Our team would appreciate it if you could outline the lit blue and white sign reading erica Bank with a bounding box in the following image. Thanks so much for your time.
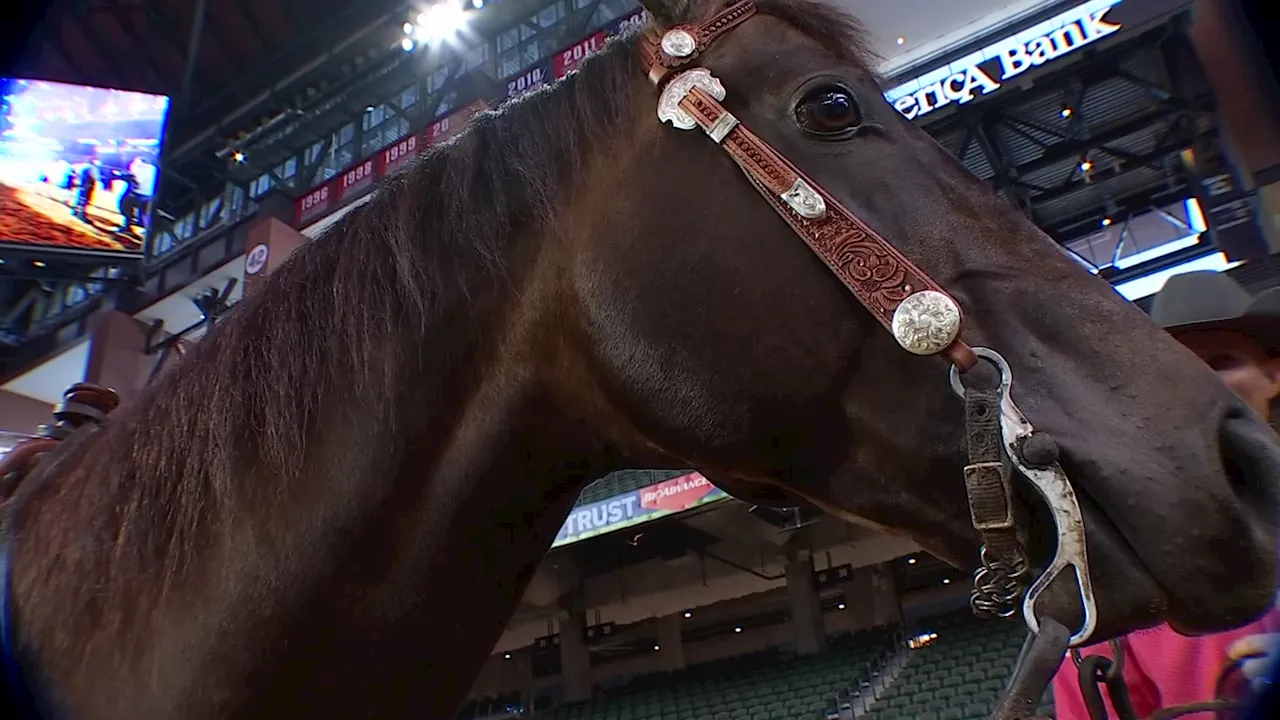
[884,0,1121,120]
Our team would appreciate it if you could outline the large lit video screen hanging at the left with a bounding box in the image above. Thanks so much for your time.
[0,78,169,252]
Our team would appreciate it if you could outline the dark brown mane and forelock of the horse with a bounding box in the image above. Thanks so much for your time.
[17,0,873,657]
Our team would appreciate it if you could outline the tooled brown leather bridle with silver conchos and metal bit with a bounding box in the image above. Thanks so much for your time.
[640,0,1097,717]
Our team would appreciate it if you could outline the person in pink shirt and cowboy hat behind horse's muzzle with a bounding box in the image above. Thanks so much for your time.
[1053,272,1280,720]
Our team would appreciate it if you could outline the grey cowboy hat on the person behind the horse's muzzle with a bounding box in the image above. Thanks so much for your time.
[1151,270,1280,354]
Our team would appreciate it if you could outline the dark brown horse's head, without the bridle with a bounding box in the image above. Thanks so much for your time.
[571,0,1280,637]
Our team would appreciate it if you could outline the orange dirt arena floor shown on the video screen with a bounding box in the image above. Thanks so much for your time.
[0,184,142,251]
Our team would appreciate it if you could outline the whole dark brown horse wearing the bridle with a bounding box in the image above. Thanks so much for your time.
[9,0,1280,720]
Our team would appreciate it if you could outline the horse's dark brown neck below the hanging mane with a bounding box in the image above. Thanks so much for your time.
[14,265,602,719]
